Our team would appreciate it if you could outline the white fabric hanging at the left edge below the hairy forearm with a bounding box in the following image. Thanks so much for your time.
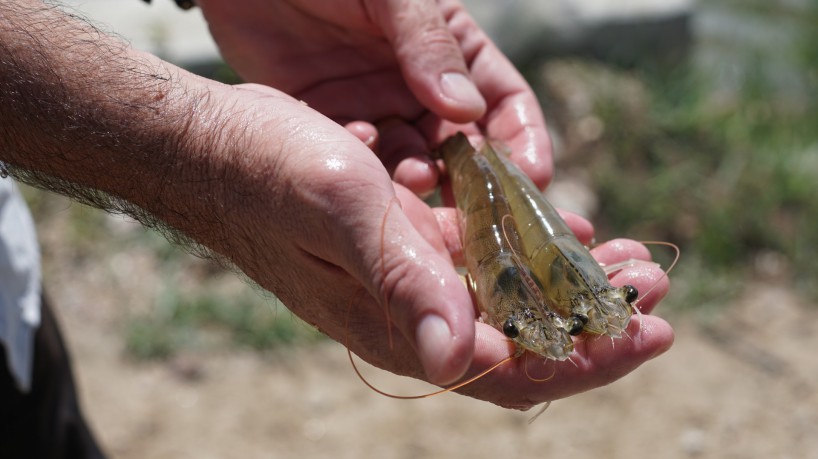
[0,178,40,391]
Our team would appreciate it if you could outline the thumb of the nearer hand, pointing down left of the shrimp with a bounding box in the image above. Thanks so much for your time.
[372,192,475,385]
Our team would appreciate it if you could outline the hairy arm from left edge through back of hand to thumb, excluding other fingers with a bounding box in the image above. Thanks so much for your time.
[0,0,474,390]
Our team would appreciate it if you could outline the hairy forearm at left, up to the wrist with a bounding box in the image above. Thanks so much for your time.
[0,1,242,255]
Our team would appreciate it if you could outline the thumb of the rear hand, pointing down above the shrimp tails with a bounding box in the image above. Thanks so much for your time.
[370,0,486,123]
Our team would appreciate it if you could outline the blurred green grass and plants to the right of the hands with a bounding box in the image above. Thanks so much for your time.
[542,2,818,306]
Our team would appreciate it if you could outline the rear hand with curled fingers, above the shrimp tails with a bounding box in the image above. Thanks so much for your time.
[197,0,551,195]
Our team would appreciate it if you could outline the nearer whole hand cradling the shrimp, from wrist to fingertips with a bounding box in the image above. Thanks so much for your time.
[196,82,672,408]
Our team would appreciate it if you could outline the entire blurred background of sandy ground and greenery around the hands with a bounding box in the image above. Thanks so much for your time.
[25,0,818,459]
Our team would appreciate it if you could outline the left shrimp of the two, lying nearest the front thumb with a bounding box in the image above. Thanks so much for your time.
[440,134,574,360]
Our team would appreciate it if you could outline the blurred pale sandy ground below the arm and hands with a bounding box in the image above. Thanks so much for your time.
[30,200,818,459]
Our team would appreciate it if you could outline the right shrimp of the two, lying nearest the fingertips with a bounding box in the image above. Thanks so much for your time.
[481,142,639,338]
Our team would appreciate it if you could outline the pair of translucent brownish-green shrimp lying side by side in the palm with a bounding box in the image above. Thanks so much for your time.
[440,133,656,360]
